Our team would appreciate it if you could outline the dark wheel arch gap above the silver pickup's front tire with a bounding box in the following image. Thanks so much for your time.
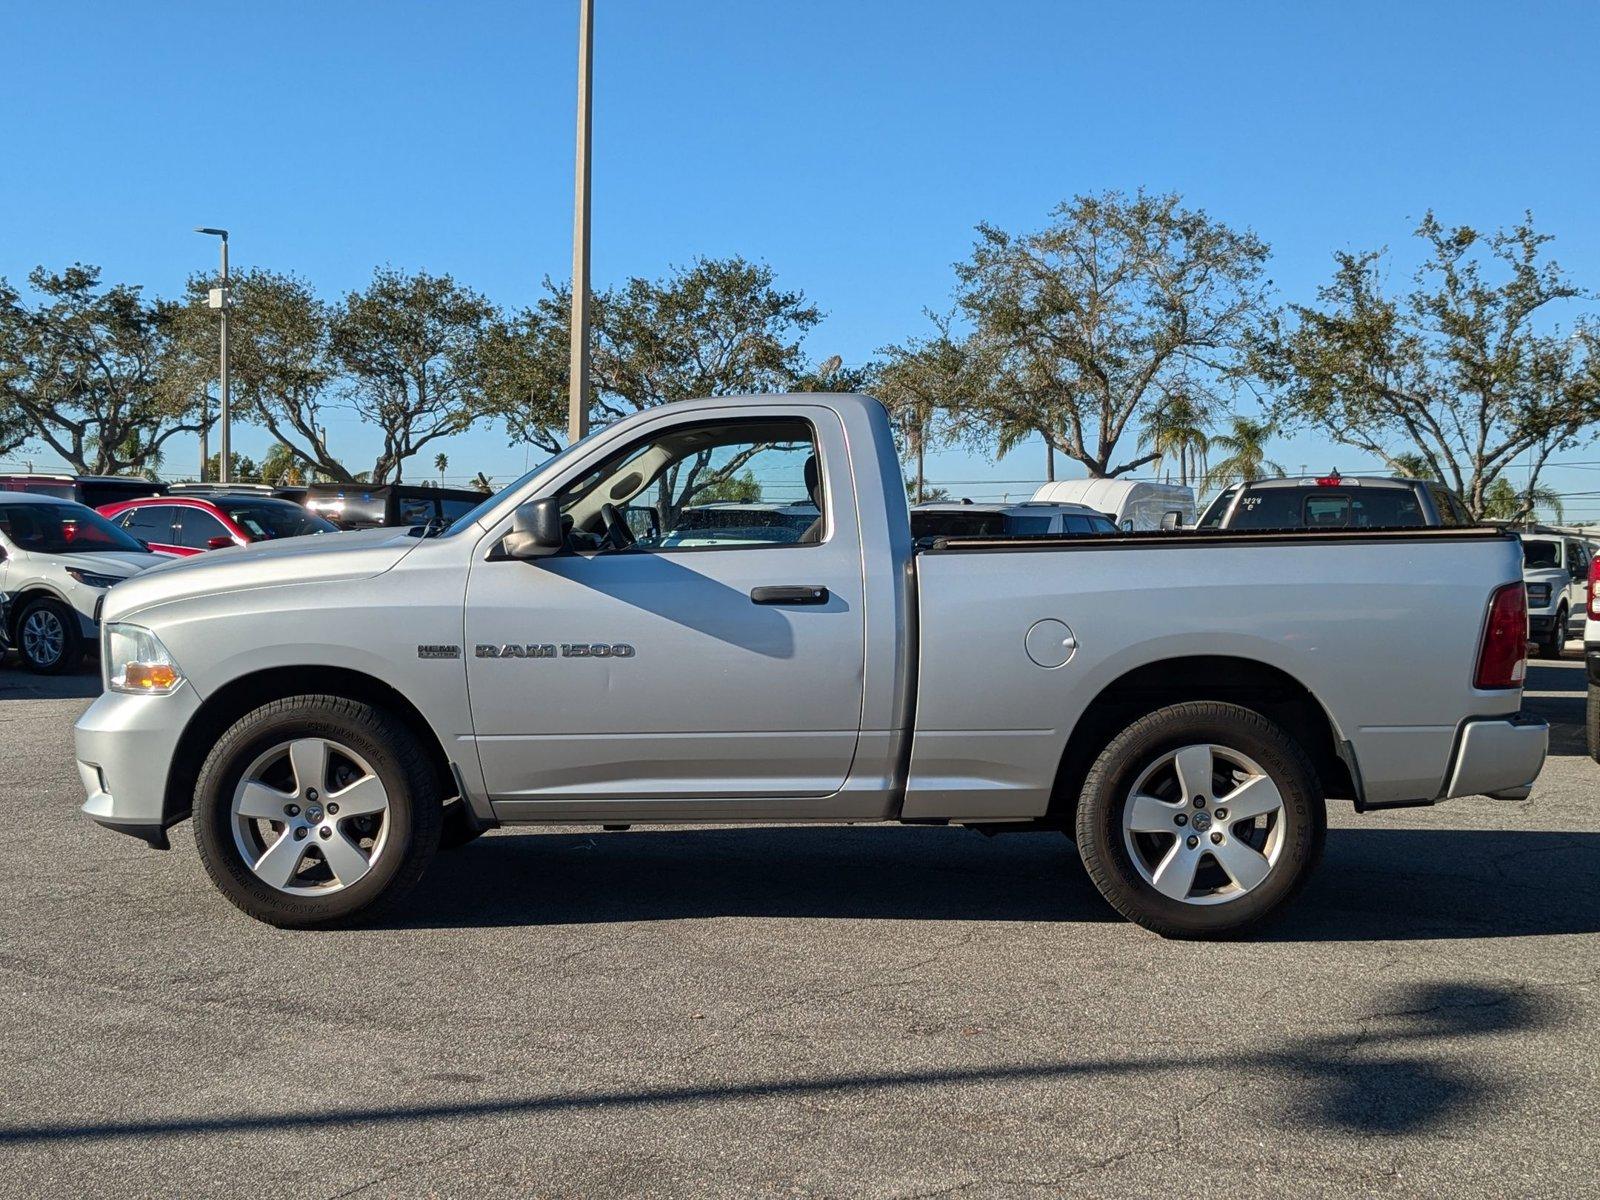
[162,664,459,827]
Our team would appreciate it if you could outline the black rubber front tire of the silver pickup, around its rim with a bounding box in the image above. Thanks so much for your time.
[194,696,442,930]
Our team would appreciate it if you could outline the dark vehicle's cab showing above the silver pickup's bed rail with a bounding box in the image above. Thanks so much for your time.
[1200,470,1477,530]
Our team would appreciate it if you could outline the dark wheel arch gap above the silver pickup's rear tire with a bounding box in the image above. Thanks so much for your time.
[1050,654,1360,829]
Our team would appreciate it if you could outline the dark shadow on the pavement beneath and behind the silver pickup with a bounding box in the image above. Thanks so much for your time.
[384,826,1600,942]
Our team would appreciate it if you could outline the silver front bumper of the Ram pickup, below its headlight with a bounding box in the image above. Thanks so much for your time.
[72,683,200,845]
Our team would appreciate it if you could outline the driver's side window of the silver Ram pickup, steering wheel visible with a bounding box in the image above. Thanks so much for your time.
[560,418,826,552]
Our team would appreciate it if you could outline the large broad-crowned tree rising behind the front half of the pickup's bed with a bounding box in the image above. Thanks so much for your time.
[955,190,1269,477]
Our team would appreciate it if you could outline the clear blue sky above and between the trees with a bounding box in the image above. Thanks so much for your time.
[0,0,1600,514]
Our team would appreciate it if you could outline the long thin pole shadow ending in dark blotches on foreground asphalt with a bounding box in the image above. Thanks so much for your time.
[0,982,1573,1154]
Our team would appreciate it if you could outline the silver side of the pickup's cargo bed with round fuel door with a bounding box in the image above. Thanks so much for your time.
[902,528,1522,821]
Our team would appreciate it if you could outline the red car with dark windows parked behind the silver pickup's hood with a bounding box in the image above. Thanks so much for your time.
[99,488,336,555]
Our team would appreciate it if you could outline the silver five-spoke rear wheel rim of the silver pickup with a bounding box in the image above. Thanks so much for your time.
[1122,742,1285,904]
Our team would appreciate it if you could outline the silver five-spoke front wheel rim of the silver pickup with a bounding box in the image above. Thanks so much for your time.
[232,738,390,896]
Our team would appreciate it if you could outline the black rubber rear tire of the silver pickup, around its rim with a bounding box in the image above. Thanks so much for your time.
[1077,701,1328,938]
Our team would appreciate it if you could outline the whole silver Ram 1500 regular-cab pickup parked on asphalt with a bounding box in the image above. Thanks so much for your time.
[77,395,1547,936]
